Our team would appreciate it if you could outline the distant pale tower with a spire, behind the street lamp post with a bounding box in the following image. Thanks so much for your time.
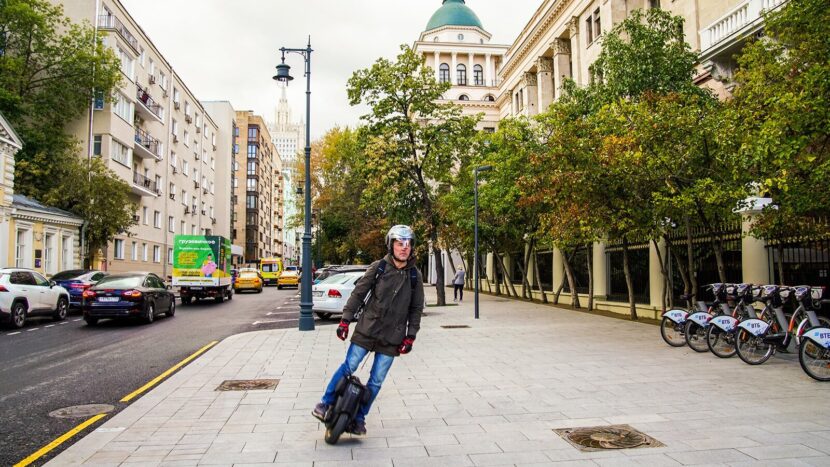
[268,83,305,265]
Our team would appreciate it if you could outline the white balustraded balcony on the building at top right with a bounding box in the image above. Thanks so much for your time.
[699,0,787,61]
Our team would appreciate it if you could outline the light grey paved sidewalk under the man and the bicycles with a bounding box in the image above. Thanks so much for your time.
[47,289,830,467]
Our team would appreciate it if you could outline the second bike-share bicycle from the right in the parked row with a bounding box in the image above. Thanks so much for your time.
[736,285,830,370]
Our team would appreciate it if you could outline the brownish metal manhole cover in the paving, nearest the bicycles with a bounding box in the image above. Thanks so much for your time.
[553,425,663,451]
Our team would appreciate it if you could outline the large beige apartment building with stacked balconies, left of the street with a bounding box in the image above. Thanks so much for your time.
[53,0,228,277]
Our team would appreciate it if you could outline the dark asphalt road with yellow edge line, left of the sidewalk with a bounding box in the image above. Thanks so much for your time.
[0,288,336,465]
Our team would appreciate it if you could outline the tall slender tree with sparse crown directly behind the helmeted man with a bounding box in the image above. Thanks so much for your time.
[348,45,477,305]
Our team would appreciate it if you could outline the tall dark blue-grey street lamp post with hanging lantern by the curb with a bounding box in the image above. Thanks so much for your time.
[274,36,314,331]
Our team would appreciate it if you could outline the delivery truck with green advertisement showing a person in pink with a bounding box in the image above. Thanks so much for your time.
[173,235,233,305]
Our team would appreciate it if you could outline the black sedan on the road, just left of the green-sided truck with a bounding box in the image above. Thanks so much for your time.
[83,272,176,326]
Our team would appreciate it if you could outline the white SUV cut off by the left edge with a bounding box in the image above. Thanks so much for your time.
[0,268,69,329]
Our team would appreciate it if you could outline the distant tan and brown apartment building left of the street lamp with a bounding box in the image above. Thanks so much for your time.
[236,110,281,263]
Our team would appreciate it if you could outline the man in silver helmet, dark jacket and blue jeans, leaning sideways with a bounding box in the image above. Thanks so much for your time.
[312,225,424,435]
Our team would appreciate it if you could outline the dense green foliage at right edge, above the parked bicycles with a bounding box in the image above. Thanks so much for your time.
[733,0,830,238]
